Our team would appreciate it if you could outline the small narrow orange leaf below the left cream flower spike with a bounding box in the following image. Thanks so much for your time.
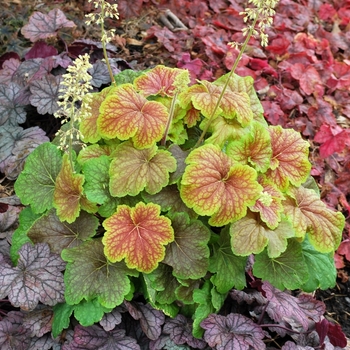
[53,154,84,223]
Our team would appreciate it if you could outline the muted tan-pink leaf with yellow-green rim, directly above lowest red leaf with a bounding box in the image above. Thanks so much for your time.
[109,141,176,197]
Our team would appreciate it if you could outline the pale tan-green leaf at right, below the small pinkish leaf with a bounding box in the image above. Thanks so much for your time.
[230,212,295,258]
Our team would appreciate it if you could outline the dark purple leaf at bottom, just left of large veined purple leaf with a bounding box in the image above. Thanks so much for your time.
[163,314,207,349]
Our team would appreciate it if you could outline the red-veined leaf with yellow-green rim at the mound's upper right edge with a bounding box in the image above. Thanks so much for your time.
[266,126,311,190]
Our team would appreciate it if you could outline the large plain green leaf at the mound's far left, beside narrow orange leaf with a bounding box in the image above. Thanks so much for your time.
[15,142,62,214]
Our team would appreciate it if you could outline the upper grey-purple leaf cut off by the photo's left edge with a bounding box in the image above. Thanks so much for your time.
[0,82,27,126]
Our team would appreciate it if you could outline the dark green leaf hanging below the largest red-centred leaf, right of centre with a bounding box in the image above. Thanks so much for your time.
[209,228,247,294]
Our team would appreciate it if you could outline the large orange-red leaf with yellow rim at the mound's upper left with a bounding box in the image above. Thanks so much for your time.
[97,84,168,148]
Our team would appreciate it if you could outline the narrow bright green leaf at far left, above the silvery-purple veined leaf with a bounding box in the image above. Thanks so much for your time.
[10,207,40,266]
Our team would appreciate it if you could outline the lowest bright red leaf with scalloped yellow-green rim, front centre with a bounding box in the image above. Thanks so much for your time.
[102,202,174,273]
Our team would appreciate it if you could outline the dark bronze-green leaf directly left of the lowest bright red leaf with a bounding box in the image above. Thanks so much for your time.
[27,209,99,254]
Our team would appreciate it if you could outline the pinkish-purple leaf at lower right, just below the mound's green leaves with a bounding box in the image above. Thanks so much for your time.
[262,282,325,331]
